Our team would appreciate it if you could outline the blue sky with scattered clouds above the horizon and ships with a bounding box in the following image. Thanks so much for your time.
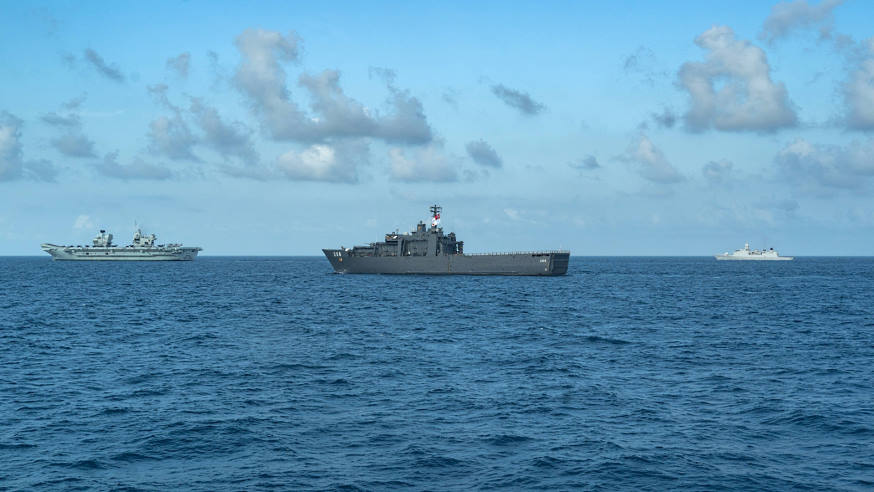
[0,0,874,256]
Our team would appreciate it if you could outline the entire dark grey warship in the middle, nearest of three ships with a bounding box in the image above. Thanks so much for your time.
[322,205,570,275]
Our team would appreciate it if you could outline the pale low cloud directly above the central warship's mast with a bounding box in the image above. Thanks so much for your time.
[389,142,458,182]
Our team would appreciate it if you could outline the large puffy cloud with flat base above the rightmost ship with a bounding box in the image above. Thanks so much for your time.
[678,26,797,132]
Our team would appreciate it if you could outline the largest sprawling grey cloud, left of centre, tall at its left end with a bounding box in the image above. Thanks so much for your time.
[234,29,432,144]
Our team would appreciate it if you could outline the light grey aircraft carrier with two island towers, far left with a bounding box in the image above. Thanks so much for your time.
[42,228,203,261]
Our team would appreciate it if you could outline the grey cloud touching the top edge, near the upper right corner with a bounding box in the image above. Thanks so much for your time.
[759,0,844,42]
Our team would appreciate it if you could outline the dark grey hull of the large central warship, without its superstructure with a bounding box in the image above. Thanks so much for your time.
[322,249,570,276]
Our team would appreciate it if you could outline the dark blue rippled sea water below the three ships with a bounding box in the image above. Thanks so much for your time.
[0,257,874,490]
